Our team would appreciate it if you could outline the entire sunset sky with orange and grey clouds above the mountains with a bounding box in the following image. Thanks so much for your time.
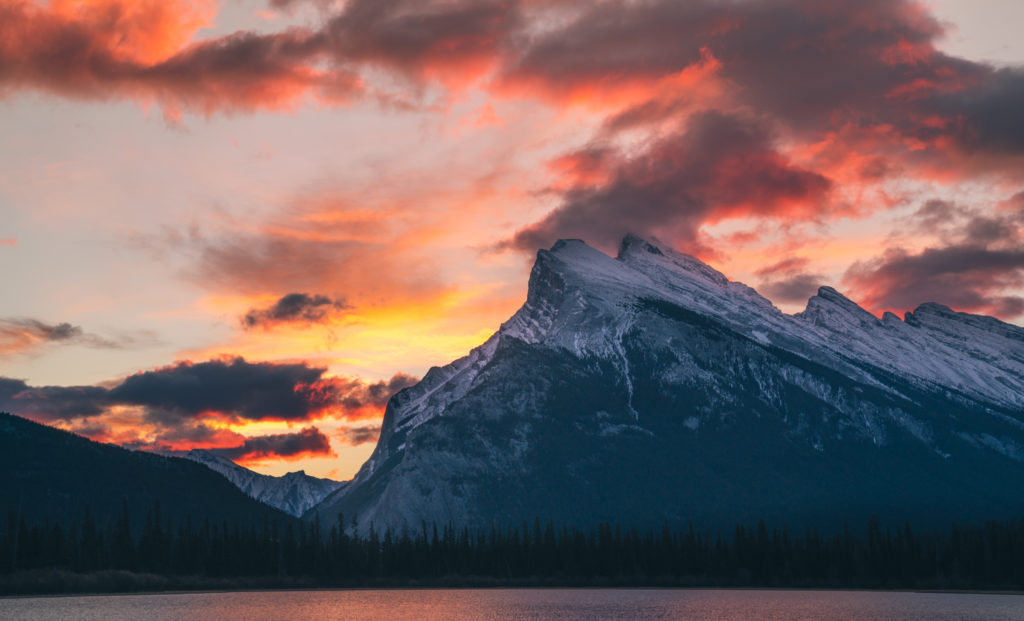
[0,0,1024,479]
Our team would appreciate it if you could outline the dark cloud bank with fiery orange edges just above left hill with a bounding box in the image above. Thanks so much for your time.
[0,358,417,460]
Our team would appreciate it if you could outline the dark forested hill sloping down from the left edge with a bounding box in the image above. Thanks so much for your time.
[0,414,292,528]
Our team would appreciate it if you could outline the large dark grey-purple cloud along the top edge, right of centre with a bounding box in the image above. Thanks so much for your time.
[505,0,966,125]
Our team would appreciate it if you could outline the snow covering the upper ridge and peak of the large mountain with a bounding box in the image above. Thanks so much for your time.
[385,236,1024,446]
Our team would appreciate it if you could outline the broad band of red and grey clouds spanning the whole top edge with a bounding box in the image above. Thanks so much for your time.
[0,0,1024,182]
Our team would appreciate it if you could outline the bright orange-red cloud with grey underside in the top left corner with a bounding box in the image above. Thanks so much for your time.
[0,0,348,114]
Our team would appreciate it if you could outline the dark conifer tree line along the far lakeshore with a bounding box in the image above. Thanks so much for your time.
[0,503,1024,589]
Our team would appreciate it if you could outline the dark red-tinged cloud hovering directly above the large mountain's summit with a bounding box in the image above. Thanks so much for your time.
[506,112,831,251]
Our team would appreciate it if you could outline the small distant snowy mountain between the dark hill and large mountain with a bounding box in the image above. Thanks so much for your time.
[181,449,345,516]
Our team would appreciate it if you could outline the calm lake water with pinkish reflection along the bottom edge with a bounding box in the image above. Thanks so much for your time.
[0,589,1024,621]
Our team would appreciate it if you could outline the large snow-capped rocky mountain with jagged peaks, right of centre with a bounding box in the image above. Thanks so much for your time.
[307,237,1024,529]
